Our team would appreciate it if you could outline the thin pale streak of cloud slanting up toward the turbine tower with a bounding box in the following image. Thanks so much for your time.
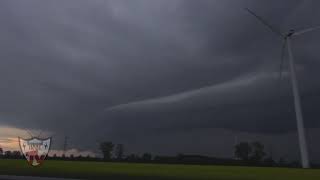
[106,73,278,112]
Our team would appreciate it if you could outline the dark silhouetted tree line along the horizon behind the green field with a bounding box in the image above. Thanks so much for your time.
[0,141,320,167]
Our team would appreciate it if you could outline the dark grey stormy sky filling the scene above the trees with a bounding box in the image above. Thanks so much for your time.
[0,0,320,160]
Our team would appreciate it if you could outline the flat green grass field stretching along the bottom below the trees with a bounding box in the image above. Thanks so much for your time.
[0,160,320,180]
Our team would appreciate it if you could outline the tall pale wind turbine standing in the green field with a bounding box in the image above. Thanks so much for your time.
[245,8,320,168]
